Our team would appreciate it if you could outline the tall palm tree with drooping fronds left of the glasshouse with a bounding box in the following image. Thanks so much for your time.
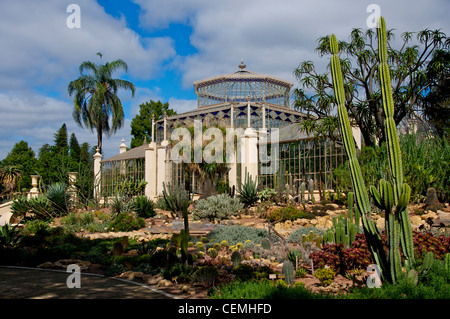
[67,52,135,153]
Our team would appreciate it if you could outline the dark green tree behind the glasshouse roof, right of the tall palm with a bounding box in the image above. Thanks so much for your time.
[131,100,177,148]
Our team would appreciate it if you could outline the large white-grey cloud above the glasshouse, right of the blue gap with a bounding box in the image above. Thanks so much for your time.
[135,0,450,88]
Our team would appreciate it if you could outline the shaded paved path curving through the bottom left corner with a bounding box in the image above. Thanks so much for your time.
[0,266,176,299]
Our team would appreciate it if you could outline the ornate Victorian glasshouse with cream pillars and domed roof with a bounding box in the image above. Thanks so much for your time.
[95,61,360,198]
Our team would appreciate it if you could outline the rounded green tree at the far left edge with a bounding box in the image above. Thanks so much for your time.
[1,141,37,189]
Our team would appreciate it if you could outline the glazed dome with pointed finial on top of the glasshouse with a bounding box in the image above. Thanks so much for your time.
[194,61,293,108]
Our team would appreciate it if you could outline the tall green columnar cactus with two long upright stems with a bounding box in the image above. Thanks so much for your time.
[330,17,414,282]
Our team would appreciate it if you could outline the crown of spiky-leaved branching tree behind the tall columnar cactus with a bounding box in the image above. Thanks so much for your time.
[293,28,450,146]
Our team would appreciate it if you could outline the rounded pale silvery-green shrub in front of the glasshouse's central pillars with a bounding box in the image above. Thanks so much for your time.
[192,194,244,222]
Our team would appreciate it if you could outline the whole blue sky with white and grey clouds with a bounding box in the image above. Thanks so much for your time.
[0,0,450,159]
